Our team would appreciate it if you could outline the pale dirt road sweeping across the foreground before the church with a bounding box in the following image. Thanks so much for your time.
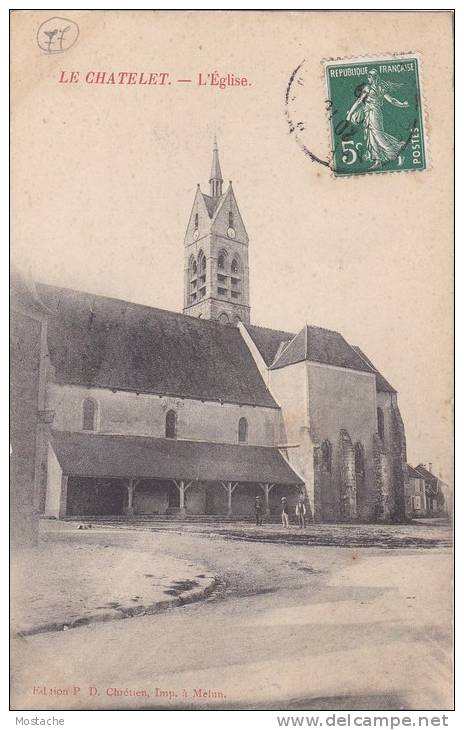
[12,527,452,710]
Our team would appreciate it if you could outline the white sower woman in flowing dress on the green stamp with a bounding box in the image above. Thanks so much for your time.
[346,69,409,170]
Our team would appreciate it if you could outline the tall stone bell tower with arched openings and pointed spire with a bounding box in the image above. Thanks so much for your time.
[183,137,250,325]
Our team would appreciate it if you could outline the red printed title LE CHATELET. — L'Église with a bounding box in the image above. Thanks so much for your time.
[58,71,251,89]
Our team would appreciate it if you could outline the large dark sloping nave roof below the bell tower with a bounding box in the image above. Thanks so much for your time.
[38,284,278,408]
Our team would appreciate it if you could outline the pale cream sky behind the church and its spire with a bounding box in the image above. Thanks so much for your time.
[12,11,453,480]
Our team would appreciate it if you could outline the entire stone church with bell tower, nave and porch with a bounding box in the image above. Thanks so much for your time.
[29,141,407,521]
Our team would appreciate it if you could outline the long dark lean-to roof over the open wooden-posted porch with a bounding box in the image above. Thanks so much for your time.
[51,431,303,484]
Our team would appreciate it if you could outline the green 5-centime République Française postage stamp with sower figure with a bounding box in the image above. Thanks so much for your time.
[324,54,428,177]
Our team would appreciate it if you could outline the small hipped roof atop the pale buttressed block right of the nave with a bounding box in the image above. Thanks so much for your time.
[271,325,372,373]
